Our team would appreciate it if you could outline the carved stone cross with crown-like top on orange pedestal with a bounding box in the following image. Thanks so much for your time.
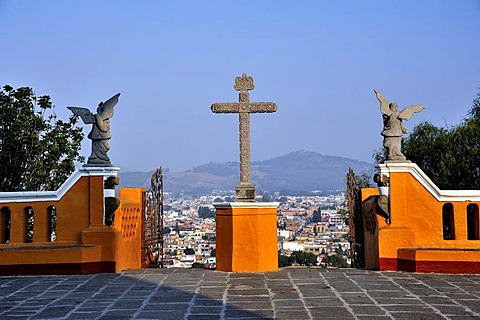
[210,73,277,202]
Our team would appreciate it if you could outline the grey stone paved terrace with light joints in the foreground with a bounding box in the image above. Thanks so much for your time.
[0,268,480,320]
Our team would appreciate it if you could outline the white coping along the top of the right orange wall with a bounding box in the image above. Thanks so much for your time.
[375,162,480,202]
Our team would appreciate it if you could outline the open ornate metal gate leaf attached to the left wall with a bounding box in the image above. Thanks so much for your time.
[142,167,163,268]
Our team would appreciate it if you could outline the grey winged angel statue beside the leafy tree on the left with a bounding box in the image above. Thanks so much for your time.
[67,93,120,167]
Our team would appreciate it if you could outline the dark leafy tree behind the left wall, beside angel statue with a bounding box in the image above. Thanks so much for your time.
[0,85,84,192]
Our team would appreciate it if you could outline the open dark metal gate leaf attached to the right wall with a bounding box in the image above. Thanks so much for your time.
[347,168,365,268]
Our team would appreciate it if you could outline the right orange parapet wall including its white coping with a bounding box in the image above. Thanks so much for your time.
[362,163,480,273]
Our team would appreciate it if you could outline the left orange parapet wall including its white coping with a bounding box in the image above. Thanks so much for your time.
[0,167,143,275]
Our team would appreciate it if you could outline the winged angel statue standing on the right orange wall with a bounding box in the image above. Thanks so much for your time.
[373,90,425,162]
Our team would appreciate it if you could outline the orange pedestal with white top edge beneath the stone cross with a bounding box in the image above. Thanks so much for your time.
[214,202,278,272]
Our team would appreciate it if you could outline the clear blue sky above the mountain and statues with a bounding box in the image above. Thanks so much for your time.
[0,0,480,171]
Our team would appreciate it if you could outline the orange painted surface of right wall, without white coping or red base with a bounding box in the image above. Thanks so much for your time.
[362,165,480,270]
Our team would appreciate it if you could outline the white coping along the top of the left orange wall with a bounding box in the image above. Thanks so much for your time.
[0,167,120,203]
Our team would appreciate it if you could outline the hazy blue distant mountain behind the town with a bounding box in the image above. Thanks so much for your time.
[120,151,373,194]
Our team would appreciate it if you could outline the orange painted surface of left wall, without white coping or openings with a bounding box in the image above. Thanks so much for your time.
[0,171,144,274]
